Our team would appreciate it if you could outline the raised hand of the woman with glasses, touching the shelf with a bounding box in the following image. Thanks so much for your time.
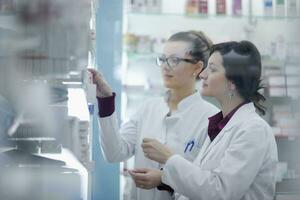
[88,69,113,97]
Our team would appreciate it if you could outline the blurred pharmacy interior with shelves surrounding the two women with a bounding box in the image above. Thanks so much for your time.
[0,0,300,200]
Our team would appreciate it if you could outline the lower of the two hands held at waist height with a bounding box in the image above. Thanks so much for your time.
[128,168,161,190]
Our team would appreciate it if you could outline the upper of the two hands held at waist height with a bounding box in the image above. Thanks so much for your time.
[142,138,174,164]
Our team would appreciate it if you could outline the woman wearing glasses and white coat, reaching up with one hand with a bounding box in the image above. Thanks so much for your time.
[89,31,218,200]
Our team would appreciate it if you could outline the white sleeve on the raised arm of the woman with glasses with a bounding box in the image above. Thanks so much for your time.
[98,104,143,162]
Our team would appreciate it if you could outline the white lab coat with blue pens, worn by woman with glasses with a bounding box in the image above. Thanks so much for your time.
[99,92,218,200]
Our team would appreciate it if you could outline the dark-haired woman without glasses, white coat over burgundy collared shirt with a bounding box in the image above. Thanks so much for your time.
[136,41,277,200]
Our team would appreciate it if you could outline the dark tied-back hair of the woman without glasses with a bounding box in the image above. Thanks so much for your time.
[210,41,266,115]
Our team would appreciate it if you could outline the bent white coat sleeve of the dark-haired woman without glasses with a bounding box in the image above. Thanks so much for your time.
[162,123,268,200]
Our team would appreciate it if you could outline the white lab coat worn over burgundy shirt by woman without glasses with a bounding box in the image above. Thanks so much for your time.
[162,103,277,200]
